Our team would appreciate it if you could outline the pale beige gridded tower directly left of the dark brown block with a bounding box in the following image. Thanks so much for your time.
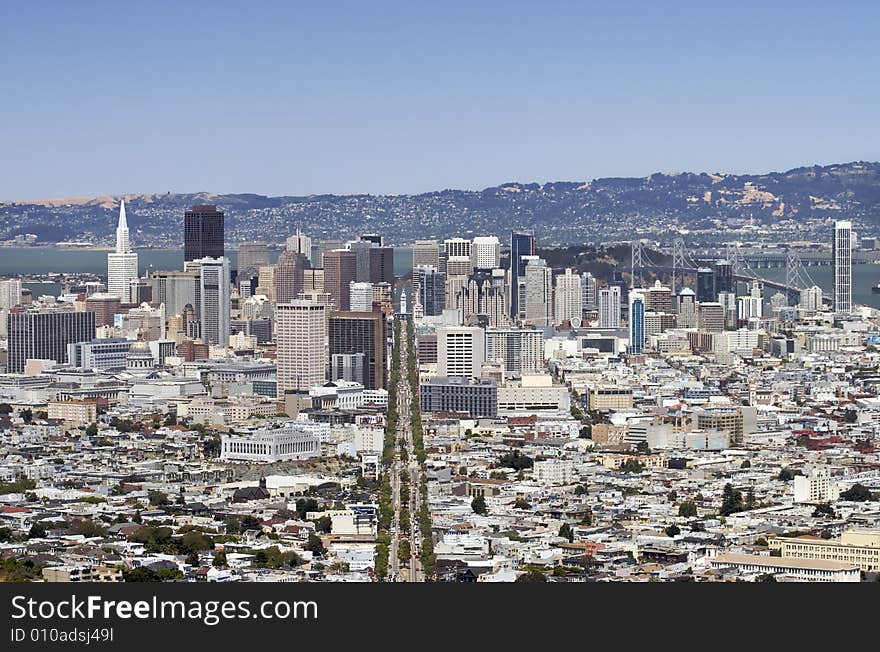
[275,301,327,399]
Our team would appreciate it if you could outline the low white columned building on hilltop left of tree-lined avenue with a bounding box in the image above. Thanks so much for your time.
[220,422,321,463]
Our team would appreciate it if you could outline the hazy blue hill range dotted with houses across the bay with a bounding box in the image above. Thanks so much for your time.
[0,162,880,247]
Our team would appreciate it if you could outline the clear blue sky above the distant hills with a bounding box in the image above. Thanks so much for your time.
[0,0,880,200]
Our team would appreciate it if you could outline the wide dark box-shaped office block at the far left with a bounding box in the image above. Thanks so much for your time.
[6,308,95,374]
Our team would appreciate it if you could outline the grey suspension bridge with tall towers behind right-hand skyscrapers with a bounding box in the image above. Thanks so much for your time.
[630,238,832,303]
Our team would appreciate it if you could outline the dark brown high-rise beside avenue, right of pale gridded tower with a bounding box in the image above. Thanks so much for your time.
[328,311,385,389]
